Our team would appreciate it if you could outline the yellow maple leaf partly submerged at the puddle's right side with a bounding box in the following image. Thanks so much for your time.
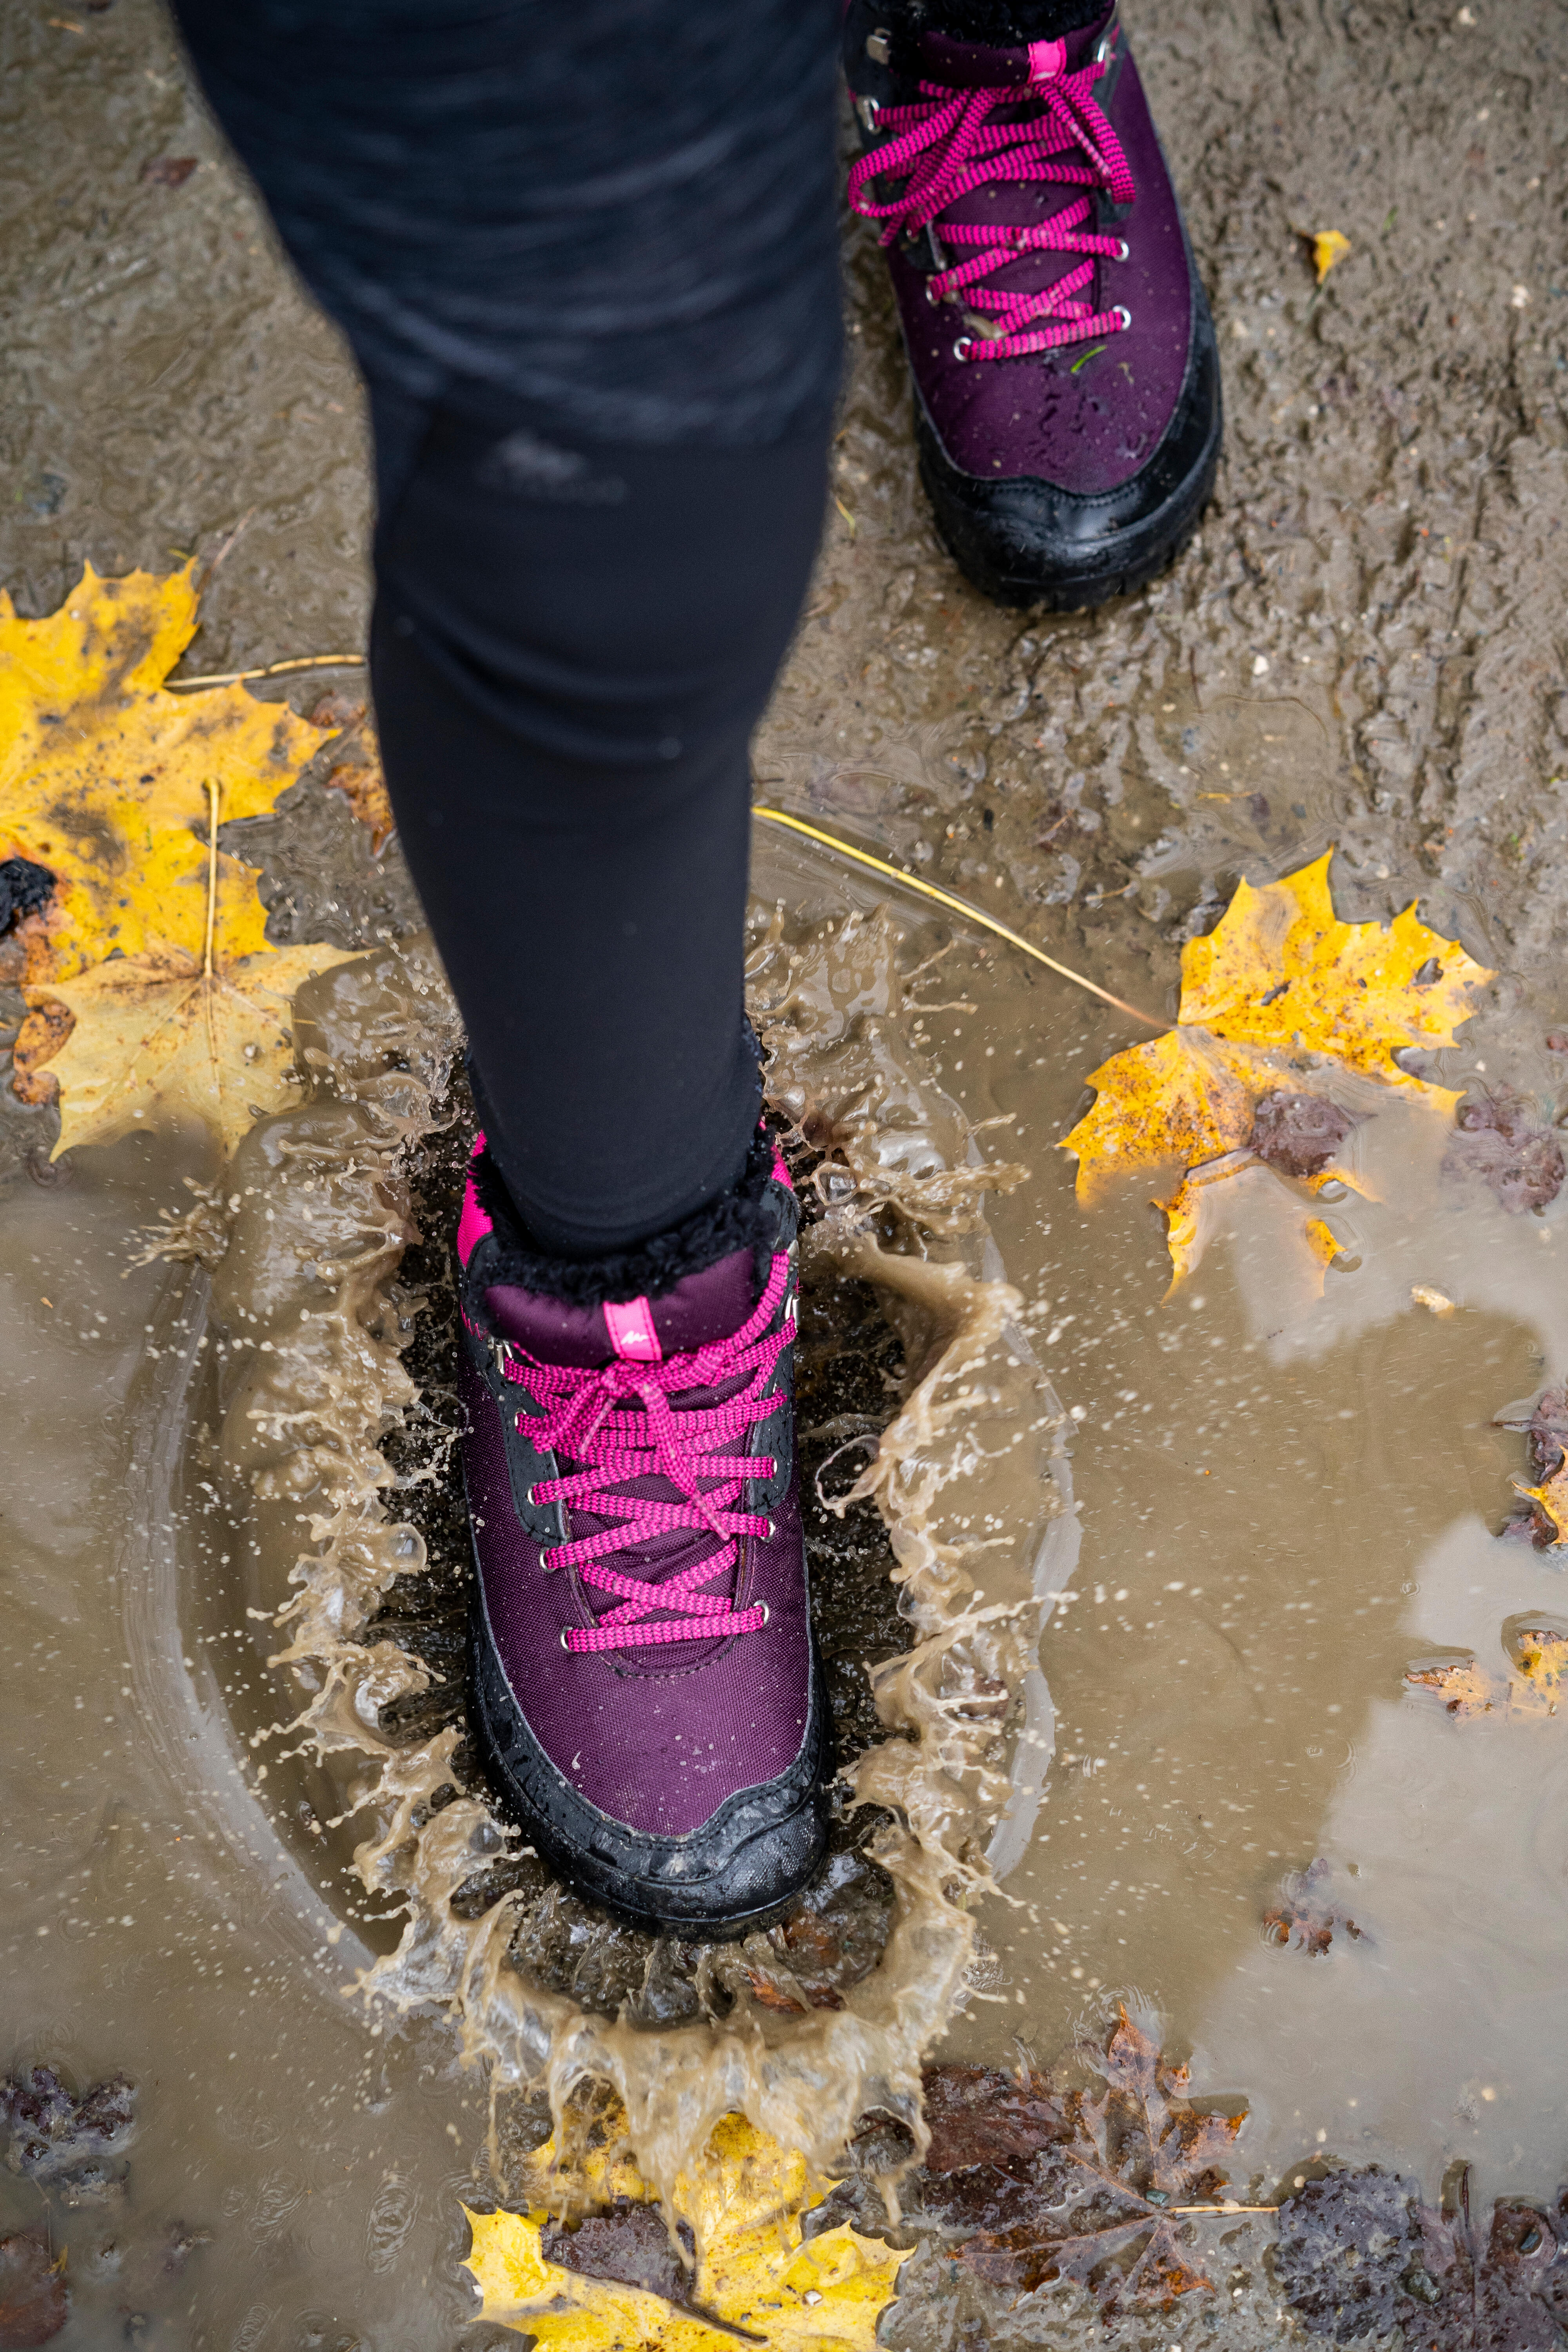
[1063,851,1493,1279]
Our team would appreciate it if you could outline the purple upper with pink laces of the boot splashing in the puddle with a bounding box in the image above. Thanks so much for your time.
[458,1138,818,1851]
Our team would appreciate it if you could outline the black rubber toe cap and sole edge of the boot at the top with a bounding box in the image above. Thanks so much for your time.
[915,275,1225,612]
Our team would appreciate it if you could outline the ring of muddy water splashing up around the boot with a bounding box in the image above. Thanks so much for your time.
[158,910,1063,2192]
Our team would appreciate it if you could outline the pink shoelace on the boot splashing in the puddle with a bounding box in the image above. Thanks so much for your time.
[503,1251,795,1653]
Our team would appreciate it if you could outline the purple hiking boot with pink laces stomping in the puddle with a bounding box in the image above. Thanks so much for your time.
[458,1134,828,1936]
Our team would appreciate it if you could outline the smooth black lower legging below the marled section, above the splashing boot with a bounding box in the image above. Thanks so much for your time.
[372,395,828,1256]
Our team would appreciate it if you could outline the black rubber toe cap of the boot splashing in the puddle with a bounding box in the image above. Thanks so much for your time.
[468,1573,832,1943]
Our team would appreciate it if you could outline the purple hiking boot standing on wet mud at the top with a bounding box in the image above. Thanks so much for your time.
[844,0,1222,612]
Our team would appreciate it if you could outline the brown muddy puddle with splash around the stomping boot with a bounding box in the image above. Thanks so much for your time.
[0,804,1568,2352]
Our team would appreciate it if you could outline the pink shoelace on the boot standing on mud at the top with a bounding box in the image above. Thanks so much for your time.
[849,42,1133,360]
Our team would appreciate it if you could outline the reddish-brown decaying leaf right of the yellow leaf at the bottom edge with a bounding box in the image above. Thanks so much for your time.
[924,2009,1243,2314]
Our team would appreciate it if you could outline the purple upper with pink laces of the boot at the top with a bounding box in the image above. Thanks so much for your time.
[846,7,1194,494]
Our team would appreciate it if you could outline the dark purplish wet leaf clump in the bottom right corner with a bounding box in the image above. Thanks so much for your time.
[1272,2164,1568,2352]
